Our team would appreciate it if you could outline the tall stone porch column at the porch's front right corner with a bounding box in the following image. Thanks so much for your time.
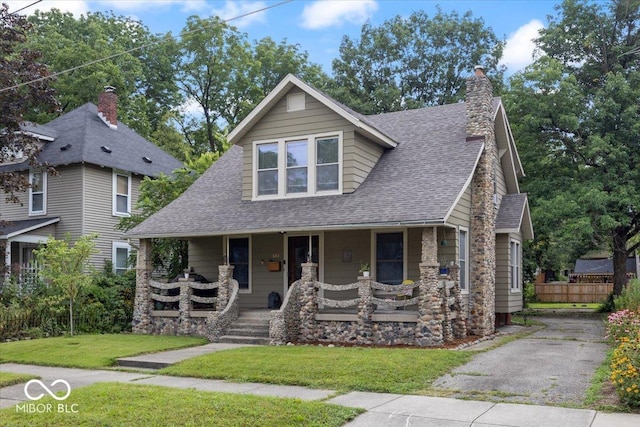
[416,227,443,347]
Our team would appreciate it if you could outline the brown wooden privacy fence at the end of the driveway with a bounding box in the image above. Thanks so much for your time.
[535,282,613,303]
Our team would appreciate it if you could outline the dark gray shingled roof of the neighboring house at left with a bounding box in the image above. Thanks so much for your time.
[0,103,183,176]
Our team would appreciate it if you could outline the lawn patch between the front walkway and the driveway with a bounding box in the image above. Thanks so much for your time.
[160,346,475,394]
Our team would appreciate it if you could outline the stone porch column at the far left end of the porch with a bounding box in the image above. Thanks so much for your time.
[131,239,153,334]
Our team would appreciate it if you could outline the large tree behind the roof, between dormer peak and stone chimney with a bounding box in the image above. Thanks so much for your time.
[330,8,504,114]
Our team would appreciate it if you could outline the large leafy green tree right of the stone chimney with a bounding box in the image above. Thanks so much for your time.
[508,0,640,294]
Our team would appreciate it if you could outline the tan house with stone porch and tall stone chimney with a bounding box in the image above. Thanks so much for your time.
[129,68,533,345]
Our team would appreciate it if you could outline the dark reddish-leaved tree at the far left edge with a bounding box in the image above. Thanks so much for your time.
[0,4,58,204]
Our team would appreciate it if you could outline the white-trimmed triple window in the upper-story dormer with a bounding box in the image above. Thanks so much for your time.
[253,132,342,199]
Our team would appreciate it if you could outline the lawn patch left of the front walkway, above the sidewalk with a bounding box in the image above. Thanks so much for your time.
[0,334,207,368]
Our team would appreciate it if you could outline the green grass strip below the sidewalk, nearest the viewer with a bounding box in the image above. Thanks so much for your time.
[0,383,364,427]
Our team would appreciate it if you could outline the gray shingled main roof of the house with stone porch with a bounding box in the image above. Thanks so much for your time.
[128,103,482,237]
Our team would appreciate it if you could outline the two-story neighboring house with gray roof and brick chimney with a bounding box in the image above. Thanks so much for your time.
[0,87,182,281]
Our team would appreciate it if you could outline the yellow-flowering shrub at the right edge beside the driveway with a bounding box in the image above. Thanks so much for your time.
[611,333,640,406]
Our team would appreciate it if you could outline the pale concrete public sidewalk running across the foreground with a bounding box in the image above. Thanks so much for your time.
[0,362,640,427]
